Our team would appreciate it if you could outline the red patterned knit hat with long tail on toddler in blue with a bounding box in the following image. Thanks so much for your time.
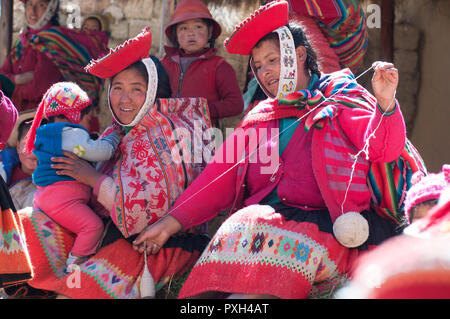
[25,82,92,153]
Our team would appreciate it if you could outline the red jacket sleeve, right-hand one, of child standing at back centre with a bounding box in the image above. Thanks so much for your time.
[208,62,244,119]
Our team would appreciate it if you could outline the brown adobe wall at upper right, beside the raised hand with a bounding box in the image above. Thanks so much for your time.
[362,0,450,172]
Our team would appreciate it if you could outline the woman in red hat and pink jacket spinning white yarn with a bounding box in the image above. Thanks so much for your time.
[134,1,426,298]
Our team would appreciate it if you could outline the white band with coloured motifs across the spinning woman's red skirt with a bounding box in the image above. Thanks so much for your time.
[197,223,337,283]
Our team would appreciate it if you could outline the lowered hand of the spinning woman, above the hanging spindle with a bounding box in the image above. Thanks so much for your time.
[133,215,181,255]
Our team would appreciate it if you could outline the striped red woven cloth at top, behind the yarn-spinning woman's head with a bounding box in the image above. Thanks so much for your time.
[289,0,368,70]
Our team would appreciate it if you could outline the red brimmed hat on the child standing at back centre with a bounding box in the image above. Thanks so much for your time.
[166,0,222,39]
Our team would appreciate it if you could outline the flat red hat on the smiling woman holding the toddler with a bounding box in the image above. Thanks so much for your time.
[84,27,152,79]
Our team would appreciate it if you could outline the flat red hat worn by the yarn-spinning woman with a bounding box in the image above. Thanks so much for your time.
[224,0,289,55]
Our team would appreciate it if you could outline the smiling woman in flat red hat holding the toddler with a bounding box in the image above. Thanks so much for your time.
[14,28,215,299]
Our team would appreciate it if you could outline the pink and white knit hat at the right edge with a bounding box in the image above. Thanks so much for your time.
[405,164,450,222]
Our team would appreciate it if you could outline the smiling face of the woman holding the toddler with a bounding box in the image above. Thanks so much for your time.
[109,68,147,125]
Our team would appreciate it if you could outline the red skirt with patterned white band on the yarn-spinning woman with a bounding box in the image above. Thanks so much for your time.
[179,205,358,299]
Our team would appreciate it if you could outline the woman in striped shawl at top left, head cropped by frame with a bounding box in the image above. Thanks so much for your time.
[0,0,107,111]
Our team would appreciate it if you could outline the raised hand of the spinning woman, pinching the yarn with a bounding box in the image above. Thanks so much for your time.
[372,61,398,112]
